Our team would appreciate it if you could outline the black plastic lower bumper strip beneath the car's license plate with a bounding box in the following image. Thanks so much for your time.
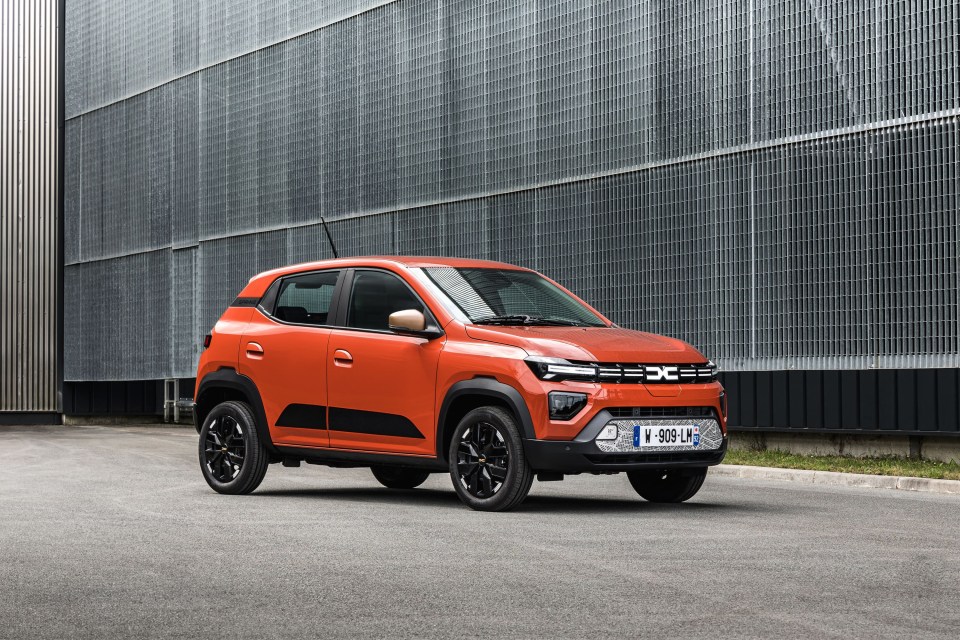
[523,437,727,473]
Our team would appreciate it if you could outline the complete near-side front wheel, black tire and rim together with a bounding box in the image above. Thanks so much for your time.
[448,407,533,511]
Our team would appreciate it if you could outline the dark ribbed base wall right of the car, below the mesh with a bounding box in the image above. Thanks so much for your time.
[720,369,960,435]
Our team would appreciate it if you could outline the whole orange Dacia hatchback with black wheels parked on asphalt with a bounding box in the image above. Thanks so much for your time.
[194,257,727,511]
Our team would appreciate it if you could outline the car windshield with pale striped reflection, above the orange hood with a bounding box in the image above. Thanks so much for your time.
[424,267,606,327]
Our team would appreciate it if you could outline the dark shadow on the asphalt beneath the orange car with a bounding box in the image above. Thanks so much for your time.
[253,487,781,514]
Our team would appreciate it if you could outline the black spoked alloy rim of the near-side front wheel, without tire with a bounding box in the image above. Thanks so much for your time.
[457,422,510,499]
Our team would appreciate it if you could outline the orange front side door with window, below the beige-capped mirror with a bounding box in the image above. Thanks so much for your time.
[327,269,443,456]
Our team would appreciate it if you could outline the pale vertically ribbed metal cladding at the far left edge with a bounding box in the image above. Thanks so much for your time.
[0,0,60,412]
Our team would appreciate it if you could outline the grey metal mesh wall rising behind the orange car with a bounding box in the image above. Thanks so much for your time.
[65,0,960,380]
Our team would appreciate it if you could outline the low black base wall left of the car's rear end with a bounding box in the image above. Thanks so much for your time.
[63,378,194,416]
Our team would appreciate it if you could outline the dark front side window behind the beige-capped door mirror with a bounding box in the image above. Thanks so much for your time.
[347,271,429,331]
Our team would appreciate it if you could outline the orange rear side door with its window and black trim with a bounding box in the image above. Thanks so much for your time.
[239,270,343,447]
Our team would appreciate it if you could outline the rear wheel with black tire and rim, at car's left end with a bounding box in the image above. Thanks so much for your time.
[199,400,270,495]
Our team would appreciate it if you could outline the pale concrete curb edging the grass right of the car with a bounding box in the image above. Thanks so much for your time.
[710,464,960,495]
